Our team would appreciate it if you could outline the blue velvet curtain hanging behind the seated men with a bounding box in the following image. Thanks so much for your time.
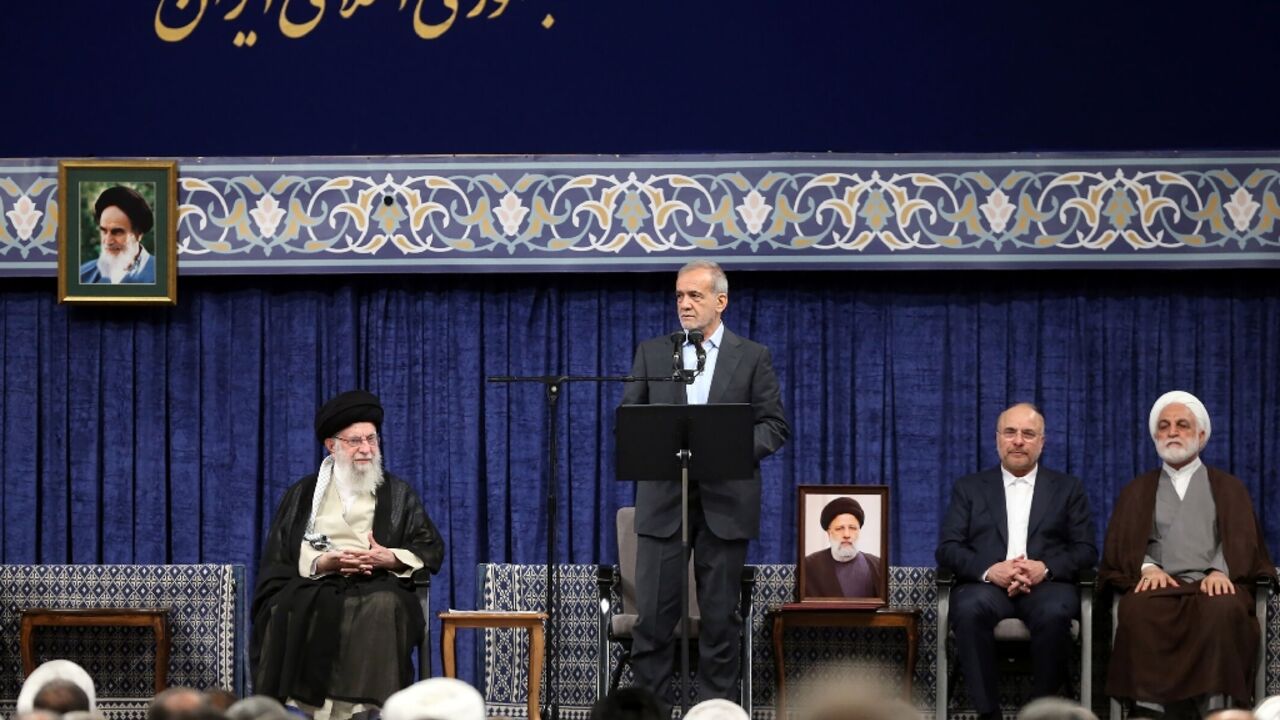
[0,270,1280,667]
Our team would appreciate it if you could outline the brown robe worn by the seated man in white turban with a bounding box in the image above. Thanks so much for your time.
[1098,465,1275,706]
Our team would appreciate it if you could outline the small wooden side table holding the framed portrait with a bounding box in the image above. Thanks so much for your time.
[772,602,920,720]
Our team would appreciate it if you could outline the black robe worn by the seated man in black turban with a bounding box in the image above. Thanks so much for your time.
[250,473,444,706]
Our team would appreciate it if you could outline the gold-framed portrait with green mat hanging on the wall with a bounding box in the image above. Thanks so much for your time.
[58,160,178,305]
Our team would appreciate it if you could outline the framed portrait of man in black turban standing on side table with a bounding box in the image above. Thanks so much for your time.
[796,486,888,609]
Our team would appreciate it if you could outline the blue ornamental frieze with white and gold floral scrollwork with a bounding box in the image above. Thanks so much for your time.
[0,154,1280,275]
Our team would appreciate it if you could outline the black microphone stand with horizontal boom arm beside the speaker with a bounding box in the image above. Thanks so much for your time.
[486,364,700,720]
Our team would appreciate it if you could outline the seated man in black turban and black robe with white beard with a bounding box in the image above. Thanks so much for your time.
[250,391,444,720]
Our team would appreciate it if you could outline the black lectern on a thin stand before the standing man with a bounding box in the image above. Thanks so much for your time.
[616,404,755,715]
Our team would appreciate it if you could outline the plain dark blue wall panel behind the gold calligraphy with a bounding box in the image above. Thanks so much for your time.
[10,0,1280,158]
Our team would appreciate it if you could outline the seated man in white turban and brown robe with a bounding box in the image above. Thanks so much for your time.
[1098,391,1275,714]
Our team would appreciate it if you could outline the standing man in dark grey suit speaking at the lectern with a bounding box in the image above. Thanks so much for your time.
[622,260,791,705]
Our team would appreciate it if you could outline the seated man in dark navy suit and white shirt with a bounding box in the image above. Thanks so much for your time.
[937,402,1098,717]
